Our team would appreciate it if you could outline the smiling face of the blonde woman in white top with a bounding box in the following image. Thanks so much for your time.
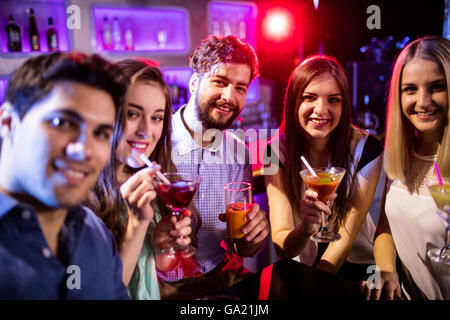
[401,58,448,139]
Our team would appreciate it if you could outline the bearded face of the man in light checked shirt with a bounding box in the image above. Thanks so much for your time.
[194,63,251,130]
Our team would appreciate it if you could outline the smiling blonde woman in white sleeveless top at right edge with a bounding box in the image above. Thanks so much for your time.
[366,37,450,299]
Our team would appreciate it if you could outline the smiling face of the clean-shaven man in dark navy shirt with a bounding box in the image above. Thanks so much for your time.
[6,82,115,208]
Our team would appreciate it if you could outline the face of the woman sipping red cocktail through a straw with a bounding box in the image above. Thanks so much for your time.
[116,81,166,168]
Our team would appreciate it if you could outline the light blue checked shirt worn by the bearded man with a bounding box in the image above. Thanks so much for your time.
[171,106,252,280]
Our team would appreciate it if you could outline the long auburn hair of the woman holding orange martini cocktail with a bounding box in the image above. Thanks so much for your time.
[280,55,352,228]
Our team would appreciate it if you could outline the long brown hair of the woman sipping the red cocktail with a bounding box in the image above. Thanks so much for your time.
[86,58,175,247]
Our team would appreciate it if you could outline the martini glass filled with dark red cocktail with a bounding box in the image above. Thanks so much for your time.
[155,172,202,258]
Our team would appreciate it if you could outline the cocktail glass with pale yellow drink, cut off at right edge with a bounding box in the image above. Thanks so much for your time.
[427,178,450,265]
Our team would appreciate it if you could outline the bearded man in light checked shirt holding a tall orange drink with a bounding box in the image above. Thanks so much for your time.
[160,36,269,297]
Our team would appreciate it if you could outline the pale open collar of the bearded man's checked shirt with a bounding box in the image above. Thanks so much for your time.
[172,105,224,158]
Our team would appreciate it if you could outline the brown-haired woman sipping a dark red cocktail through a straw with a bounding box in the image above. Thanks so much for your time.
[86,59,197,299]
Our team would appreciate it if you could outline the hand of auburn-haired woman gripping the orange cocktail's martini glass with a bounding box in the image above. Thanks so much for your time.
[300,190,336,235]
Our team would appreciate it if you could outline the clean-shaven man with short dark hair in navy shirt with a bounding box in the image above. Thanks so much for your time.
[0,53,128,299]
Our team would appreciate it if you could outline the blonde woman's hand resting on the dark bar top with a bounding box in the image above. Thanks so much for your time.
[360,271,403,300]
